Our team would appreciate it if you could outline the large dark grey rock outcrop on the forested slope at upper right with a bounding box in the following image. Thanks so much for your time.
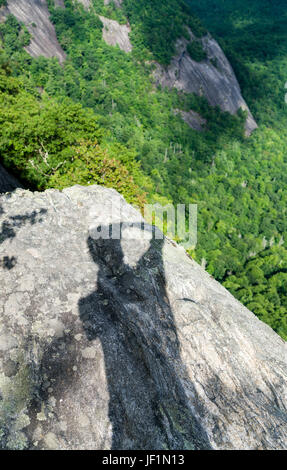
[154,31,257,135]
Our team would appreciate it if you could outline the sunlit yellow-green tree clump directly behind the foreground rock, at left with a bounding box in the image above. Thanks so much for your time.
[0,65,148,207]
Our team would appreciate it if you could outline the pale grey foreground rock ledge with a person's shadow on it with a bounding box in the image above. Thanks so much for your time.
[0,186,287,449]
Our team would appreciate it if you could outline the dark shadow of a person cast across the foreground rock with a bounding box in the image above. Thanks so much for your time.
[79,223,211,449]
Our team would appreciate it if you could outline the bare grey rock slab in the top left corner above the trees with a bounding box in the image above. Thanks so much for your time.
[0,0,66,63]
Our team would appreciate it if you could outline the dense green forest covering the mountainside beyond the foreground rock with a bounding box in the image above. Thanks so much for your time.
[0,0,287,339]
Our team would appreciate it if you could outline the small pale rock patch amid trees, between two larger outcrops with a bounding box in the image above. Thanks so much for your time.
[99,16,132,52]
